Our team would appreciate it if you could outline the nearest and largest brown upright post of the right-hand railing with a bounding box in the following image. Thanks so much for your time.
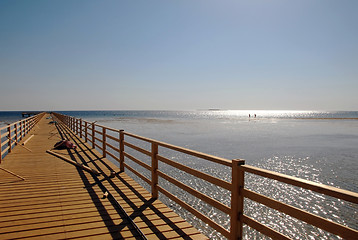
[230,159,245,240]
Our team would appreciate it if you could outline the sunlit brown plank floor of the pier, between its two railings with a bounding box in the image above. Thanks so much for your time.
[0,115,207,240]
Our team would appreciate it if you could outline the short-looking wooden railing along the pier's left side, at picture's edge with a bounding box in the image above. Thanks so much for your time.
[0,113,45,163]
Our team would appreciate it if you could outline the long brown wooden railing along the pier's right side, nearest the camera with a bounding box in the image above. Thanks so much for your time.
[54,113,358,239]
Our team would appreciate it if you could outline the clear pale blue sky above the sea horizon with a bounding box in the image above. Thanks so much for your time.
[0,0,358,110]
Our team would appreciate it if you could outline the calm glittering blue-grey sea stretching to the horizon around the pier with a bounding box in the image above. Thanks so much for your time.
[0,110,358,239]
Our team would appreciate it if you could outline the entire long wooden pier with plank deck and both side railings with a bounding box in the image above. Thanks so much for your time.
[0,113,358,240]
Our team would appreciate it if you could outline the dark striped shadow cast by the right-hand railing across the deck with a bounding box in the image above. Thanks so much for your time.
[56,121,204,239]
